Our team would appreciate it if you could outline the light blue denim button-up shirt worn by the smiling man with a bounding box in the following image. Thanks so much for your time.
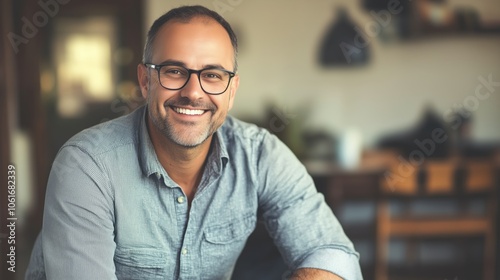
[27,107,362,280]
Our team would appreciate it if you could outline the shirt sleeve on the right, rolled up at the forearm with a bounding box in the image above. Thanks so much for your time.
[256,133,363,280]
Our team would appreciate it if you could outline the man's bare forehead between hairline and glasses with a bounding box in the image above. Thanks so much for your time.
[153,17,234,67]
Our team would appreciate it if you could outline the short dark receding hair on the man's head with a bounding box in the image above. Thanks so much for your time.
[142,5,238,71]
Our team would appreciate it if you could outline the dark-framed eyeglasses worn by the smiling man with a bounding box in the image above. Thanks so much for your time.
[144,63,236,95]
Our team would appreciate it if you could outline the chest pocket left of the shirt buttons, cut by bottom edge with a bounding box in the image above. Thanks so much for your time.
[114,248,167,280]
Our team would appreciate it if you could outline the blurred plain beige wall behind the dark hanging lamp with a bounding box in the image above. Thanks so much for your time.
[144,0,500,146]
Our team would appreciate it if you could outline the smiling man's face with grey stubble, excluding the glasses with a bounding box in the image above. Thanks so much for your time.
[138,18,239,147]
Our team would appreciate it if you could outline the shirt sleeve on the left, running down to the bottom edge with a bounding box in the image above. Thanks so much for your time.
[42,146,116,279]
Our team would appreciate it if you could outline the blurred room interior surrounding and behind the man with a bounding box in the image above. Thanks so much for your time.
[0,0,500,280]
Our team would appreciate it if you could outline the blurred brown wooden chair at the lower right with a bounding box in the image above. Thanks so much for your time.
[375,159,498,280]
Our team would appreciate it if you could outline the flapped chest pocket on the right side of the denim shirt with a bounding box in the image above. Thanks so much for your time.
[201,214,256,279]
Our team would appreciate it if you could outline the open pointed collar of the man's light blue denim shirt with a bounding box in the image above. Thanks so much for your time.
[138,105,229,177]
